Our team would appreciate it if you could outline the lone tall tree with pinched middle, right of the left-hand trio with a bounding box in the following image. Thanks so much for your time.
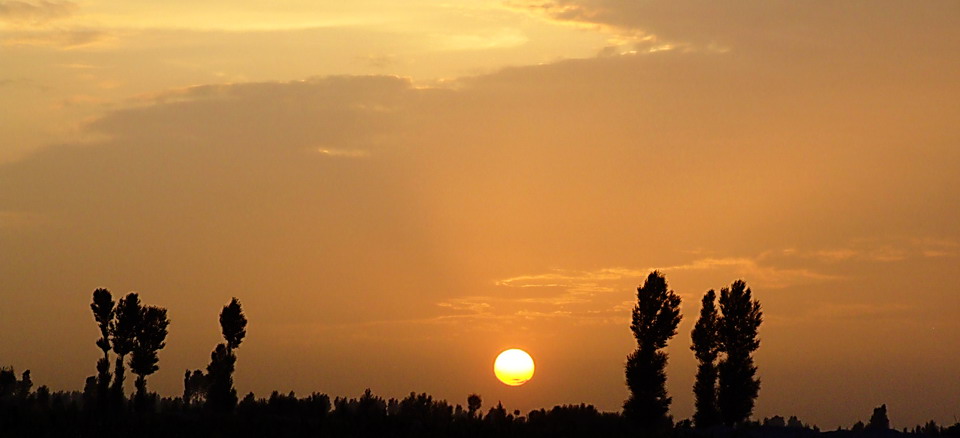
[207,297,247,412]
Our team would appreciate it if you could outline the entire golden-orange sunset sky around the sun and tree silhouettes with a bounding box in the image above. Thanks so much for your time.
[0,0,960,428]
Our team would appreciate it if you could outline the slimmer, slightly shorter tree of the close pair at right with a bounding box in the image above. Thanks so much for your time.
[690,289,720,428]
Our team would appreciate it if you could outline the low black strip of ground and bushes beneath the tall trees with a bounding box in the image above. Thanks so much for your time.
[0,384,960,438]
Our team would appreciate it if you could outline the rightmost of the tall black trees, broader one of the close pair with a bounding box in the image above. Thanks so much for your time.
[717,280,763,426]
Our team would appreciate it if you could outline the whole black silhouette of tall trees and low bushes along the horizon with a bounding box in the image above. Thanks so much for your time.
[0,271,960,438]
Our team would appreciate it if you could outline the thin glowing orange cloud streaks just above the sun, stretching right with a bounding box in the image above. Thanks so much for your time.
[310,239,958,336]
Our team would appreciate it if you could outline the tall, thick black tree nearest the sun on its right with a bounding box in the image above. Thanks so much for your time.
[623,271,681,430]
